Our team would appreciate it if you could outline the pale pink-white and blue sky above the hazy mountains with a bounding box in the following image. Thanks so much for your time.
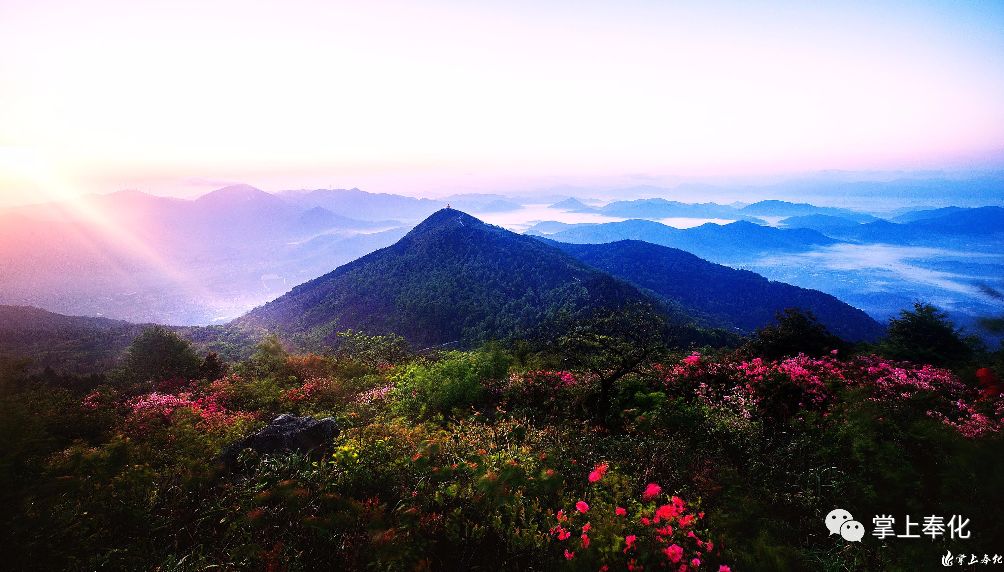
[0,0,1004,206]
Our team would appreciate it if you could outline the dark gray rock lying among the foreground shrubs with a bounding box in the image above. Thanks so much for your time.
[220,413,338,467]
